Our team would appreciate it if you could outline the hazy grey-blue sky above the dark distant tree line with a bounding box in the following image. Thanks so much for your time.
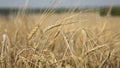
[0,0,120,8]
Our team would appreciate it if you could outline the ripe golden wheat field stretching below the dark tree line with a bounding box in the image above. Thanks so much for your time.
[0,12,120,68]
